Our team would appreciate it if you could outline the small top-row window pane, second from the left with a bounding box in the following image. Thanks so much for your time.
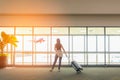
[16,27,32,34]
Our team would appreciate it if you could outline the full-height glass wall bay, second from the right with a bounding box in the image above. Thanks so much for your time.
[87,27,105,65]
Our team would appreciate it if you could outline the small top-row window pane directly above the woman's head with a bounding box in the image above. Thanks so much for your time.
[52,27,68,34]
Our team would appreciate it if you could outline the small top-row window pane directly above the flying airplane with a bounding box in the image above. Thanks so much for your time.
[34,27,50,34]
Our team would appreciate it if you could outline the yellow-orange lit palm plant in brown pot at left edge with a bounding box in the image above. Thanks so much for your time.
[0,31,18,68]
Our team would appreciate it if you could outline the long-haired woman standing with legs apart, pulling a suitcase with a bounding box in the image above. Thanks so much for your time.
[50,38,67,72]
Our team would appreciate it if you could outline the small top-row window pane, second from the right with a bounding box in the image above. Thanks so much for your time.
[88,27,104,34]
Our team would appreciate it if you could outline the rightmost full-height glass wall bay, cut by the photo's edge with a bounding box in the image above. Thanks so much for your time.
[106,27,120,65]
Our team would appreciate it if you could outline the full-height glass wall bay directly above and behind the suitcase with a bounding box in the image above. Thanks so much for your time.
[70,27,87,65]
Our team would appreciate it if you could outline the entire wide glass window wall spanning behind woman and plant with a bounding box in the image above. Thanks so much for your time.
[0,26,120,66]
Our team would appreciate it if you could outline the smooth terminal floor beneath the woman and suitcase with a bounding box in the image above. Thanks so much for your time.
[0,67,120,80]
